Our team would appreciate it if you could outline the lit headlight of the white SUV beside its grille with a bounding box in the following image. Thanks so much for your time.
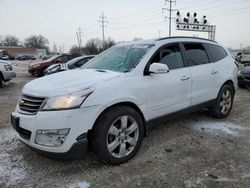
[42,88,93,110]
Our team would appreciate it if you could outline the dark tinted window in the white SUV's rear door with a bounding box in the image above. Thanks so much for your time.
[184,43,209,66]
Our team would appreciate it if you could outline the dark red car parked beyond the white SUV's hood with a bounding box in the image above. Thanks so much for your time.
[28,54,80,76]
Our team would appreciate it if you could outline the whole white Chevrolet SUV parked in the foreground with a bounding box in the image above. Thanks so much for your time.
[11,37,238,164]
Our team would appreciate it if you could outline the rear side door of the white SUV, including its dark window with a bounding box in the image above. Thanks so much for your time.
[183,42,218,106]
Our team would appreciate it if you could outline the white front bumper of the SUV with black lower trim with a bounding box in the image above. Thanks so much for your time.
[11,106,99,159]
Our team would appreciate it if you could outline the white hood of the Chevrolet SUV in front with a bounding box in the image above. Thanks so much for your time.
[22,69,122,97]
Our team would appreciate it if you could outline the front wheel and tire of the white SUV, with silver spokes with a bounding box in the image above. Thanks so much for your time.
[90,106,144,165]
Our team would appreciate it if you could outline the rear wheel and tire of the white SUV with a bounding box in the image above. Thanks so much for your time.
[210,85,234,118]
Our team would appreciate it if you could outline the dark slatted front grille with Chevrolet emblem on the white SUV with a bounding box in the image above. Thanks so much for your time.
[18,94,46,114]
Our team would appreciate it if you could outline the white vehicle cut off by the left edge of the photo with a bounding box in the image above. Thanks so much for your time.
[0,60,16,87]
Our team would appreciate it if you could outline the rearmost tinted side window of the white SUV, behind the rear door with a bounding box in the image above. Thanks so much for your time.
[205,44,227,62]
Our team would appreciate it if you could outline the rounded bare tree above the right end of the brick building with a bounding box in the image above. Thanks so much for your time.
[24,35,49,49]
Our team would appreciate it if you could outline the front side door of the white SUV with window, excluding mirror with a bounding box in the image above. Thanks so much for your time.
[145,44,192,119]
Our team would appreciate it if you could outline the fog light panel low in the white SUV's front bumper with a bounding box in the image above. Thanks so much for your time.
[35,128,70,147]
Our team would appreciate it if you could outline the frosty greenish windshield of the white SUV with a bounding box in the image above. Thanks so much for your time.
[82,44,153,72]
